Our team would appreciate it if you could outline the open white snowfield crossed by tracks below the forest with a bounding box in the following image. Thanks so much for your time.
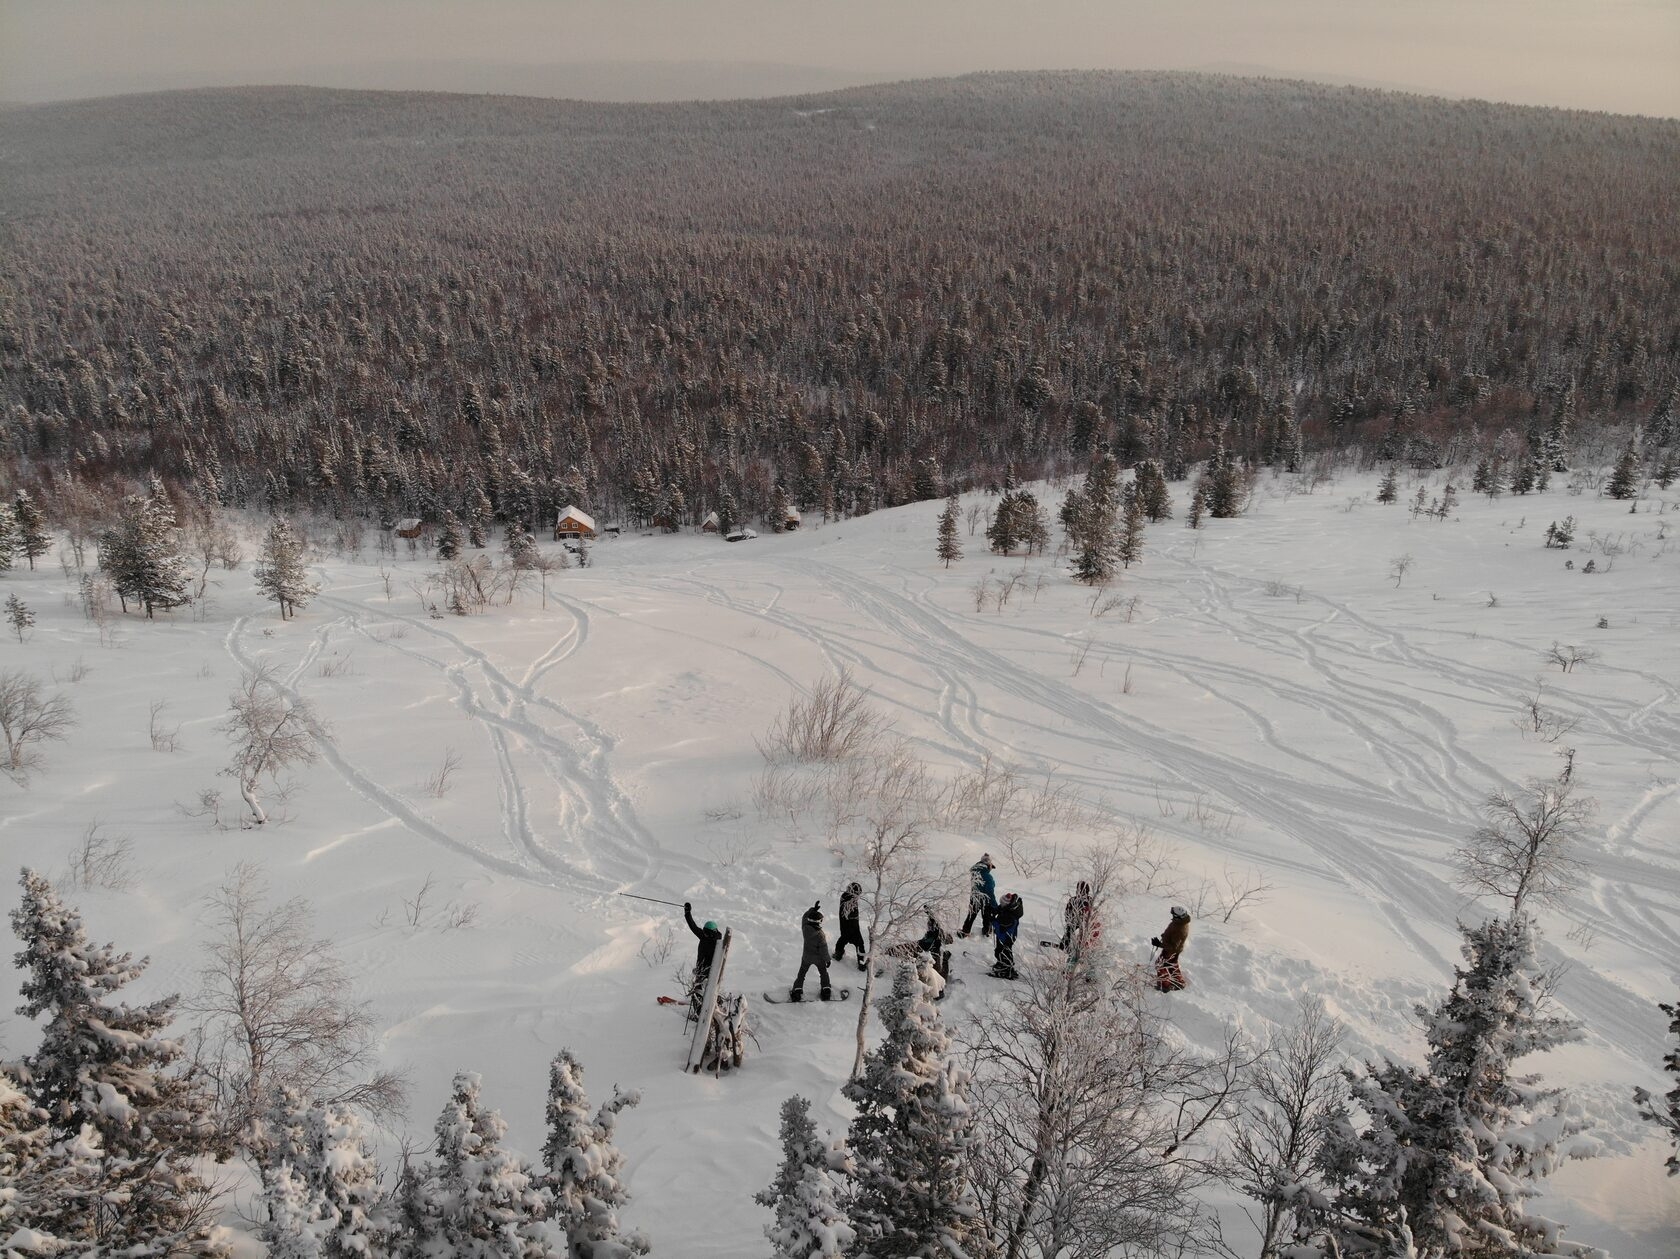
[0,476,1680,1259]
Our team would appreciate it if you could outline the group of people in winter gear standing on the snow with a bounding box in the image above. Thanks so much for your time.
[682,852,1189,1009]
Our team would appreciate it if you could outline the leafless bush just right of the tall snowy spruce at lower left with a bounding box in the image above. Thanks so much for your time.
[193,864,407,1162]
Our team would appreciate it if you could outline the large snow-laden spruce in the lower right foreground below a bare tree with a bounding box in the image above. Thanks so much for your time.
[1307,914,1589,1259]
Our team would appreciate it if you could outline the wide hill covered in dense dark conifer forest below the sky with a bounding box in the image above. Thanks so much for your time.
[0,74,1680,519]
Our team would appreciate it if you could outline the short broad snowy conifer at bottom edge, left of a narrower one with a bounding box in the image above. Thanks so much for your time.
[405,1071,566,1259]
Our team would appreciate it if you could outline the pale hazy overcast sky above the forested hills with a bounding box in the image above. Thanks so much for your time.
[0,0,1680,116]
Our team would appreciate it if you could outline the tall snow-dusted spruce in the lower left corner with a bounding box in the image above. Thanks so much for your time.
[12,869,227,1256]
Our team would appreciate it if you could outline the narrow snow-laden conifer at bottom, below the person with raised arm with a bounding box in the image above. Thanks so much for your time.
[541,1049,648,1259]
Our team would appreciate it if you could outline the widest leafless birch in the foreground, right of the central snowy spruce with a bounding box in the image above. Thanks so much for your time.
[968,945,1245,1259]
